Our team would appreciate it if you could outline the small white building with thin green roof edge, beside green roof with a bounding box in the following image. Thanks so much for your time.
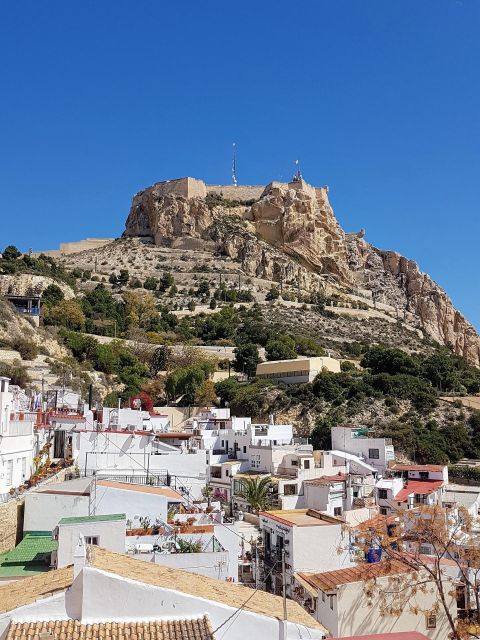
[52,513,125,568]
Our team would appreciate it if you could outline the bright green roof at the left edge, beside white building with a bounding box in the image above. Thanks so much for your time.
[0,531,57,578]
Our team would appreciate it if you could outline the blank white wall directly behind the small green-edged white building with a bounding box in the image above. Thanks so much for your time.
[23,492,90,531]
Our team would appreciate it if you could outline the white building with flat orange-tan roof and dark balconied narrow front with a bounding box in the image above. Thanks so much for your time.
[259,509,353,595]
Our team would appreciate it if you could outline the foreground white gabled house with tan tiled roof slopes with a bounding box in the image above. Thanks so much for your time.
[0,547,326,640]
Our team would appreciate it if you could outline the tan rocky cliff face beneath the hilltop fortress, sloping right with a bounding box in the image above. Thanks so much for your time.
[124,179,480,365]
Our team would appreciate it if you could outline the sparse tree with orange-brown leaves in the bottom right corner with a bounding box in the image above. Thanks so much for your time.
[354,505,480,640]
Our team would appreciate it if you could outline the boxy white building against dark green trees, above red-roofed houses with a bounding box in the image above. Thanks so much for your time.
[332,427,395,474]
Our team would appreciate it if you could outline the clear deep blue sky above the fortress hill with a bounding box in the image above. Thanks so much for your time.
[0,0,480,327]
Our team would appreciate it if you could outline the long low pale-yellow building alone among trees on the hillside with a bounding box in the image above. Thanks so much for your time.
[257,356,340,384]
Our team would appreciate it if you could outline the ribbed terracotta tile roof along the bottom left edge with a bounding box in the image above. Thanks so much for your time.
[6,616,213,640]
